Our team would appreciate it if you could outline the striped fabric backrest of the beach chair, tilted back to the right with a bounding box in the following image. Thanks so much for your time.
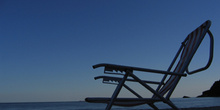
[153,20,211,98]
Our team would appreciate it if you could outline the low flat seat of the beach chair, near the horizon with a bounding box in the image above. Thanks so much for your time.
[85,97,161,106]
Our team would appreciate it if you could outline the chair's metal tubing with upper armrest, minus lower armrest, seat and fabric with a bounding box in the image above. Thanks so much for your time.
[93,20,214,110]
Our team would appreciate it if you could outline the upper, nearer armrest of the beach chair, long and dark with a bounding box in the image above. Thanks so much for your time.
[93,63,187,76]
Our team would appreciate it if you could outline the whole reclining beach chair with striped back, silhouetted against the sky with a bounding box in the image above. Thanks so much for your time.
[85,20,214,110]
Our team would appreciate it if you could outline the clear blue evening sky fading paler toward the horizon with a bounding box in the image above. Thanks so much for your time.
[0,0,220,102]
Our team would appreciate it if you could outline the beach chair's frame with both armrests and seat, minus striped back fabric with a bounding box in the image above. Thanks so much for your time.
[85,20,214,110]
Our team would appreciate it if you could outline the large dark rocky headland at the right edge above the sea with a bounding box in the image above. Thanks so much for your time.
[198,80,220,97]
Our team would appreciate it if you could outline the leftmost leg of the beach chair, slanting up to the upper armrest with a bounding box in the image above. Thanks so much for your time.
[105,72,130,110]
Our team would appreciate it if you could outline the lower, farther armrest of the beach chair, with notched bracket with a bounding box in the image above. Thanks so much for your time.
[94,76,164,84]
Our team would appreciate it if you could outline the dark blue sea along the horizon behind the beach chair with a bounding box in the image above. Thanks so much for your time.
[0,98,220,110]
